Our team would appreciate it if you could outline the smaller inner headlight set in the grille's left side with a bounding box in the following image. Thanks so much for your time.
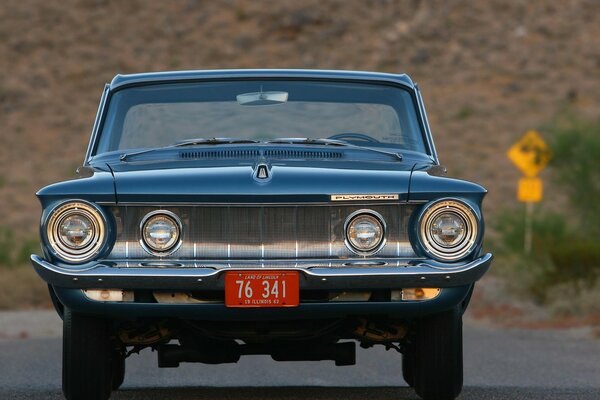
[140,210,181,256]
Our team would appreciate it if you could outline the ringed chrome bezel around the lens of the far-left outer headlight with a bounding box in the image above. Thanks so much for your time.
[44,200,107,264]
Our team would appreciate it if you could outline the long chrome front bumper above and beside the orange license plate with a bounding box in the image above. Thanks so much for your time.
[31,253,492,290]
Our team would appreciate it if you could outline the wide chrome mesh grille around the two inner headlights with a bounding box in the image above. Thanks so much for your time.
[108,204,415,260]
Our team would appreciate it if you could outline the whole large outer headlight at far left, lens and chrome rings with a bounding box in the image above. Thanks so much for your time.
[46,201,106,263]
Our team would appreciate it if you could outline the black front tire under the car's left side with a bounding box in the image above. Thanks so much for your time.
[62,308,114,400]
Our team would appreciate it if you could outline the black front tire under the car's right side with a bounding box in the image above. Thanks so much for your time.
[414,307,463,400]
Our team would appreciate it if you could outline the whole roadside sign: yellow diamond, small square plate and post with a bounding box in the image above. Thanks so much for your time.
[506,130,552,255]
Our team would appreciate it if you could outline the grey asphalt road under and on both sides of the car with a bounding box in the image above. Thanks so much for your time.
[0,316,600,400]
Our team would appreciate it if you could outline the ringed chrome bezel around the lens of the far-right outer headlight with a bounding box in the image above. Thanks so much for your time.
[418,198,481,262]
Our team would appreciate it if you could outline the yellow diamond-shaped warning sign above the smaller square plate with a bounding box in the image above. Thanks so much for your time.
[506,130,552,178]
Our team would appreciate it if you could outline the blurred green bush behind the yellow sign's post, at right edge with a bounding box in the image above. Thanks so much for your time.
[491,112,600,302]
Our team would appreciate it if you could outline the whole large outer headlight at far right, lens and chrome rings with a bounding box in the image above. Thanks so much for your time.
[419,200,479,261]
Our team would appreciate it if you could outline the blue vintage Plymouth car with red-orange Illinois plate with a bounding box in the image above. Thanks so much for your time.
[31,70,492,400]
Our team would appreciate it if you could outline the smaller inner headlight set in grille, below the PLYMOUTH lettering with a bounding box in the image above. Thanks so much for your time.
[346,210,385,255]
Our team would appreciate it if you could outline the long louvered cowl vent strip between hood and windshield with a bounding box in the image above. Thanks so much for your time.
[179,149,344,160]
